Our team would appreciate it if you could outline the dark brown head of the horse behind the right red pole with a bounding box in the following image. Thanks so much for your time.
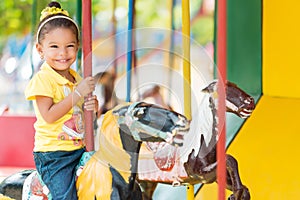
[202,81,255,119]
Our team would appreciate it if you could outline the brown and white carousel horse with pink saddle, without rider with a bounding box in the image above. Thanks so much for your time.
[137,81,255,200]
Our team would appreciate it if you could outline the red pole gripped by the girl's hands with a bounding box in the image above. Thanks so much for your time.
[82,0,94,151]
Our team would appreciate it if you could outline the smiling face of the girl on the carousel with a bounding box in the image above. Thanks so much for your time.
[36,27,79,71]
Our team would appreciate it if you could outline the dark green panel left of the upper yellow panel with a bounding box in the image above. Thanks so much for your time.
[227,0,262,96]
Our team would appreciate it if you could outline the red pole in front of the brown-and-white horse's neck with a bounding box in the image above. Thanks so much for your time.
[217,0,227,200]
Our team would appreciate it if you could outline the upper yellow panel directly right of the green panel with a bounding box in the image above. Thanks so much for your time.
[264,0,300,97]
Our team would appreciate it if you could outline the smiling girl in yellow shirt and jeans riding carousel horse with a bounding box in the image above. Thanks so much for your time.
[25,2,98,200]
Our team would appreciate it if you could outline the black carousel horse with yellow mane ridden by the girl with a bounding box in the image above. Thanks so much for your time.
[0,102,189,200]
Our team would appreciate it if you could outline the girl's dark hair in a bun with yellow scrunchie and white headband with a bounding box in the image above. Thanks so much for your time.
[36,1,79,43]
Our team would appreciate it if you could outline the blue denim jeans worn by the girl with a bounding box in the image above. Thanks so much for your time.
[33,148,85,200]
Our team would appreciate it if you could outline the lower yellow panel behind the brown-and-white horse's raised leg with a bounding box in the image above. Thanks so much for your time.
[196,96,300,200]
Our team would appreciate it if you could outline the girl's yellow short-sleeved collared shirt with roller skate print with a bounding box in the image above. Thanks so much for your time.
[25,62,84,152]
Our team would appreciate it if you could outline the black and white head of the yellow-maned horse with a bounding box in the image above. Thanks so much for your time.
[113,102,190,146]
